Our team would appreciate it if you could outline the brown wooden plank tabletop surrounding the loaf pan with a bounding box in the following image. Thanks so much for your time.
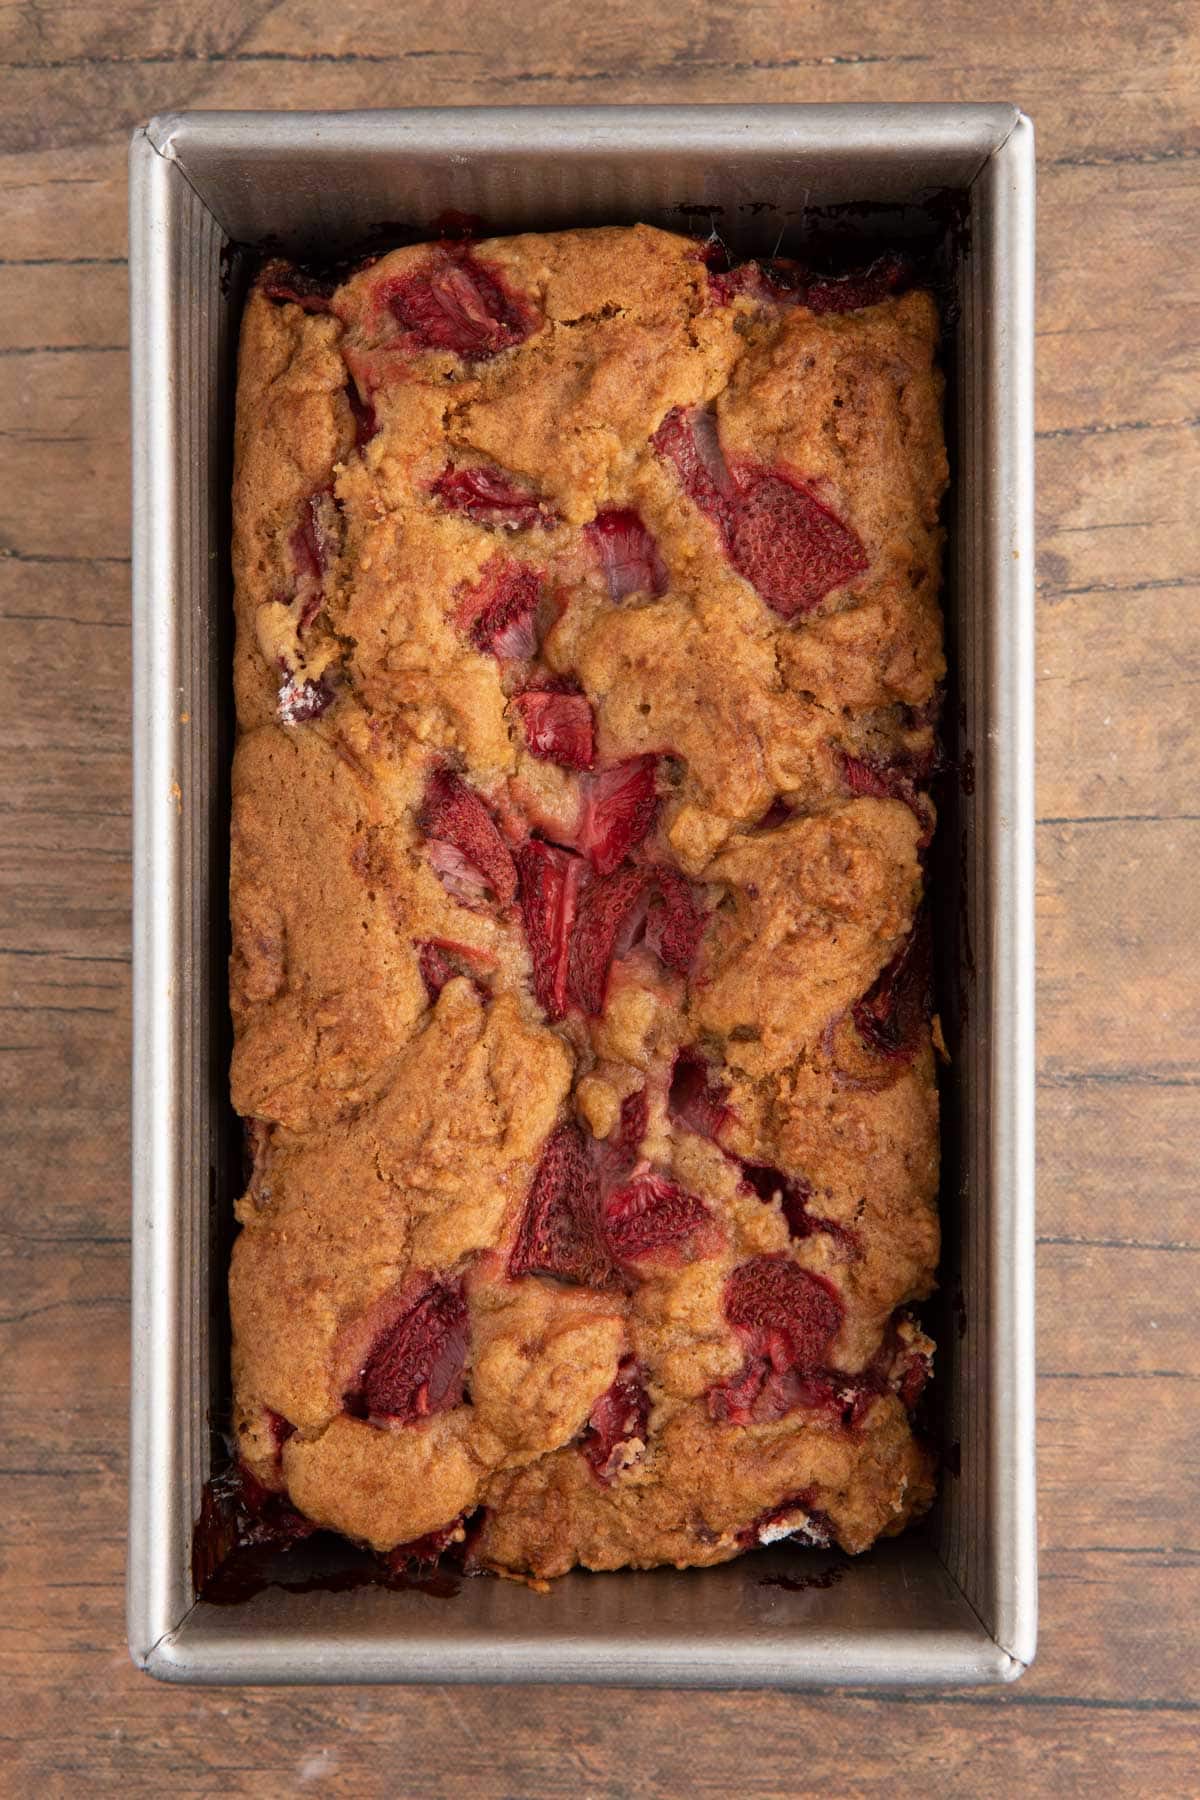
[0,0,1200,1800]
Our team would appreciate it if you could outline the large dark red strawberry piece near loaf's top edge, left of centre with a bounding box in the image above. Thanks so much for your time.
[376,248,538,362]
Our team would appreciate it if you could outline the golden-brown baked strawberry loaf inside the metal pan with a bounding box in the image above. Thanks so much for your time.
[230,227,946,1579]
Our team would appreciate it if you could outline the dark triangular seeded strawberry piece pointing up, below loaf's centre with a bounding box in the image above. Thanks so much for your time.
[509,1125,615,1287]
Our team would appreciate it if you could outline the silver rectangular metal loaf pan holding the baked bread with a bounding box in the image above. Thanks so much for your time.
[130,106,1036,1687]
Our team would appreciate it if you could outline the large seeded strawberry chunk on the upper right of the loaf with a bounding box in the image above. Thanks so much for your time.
[729,468,867,619]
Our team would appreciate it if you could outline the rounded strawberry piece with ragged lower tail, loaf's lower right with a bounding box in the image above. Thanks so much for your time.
[709,1253,844,1424]
